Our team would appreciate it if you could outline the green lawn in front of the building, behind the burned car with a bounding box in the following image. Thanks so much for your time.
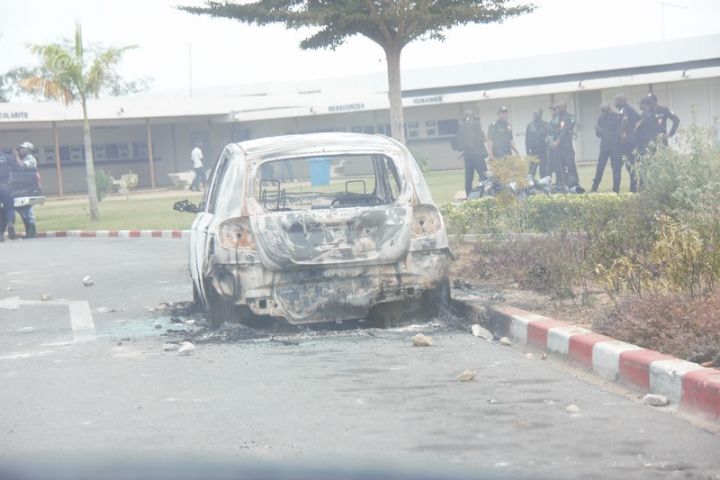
[22,165,628,232]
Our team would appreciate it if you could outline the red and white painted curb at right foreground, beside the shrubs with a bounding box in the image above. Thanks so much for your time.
[486,307,720,421]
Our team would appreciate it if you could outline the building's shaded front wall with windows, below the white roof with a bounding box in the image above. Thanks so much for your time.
[0,78,720,194]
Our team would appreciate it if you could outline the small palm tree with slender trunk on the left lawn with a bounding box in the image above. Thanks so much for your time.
[19,22,135,221]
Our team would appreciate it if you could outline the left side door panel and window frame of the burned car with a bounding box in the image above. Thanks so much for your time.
[190,152,229,303]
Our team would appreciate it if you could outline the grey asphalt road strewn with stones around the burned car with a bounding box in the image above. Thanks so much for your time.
[0,239,720,478]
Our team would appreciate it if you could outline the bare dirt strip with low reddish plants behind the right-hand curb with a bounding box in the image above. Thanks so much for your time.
[451,243,720,367]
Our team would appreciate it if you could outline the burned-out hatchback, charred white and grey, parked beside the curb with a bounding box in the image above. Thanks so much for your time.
[181,133,450,326]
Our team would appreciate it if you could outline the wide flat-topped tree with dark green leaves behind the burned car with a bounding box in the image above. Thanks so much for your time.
[178,0,535,142]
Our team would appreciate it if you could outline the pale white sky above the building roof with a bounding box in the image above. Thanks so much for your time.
[0,0,720,91]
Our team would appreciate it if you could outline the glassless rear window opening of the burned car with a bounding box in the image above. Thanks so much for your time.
[253,154,402,211]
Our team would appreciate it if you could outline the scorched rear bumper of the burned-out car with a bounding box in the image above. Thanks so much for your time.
[210,248,451,324]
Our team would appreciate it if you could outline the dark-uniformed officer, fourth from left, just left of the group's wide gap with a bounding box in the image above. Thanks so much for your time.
[549,102,584,188]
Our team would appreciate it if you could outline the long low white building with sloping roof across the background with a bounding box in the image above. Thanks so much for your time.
[0,35,720,193]
